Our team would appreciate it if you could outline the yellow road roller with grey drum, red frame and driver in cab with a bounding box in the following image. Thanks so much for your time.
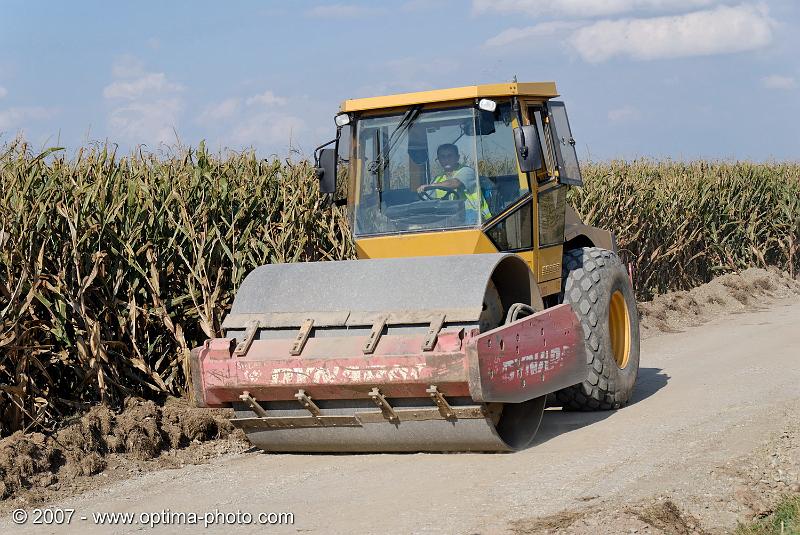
[190,81,639,452]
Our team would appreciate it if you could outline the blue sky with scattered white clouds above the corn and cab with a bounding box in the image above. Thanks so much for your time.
[0,0,800,160]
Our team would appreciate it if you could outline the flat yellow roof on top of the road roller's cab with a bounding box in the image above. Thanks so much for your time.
[339,82,558,112]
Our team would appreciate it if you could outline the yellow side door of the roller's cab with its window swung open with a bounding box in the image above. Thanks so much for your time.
[524,102,583,296]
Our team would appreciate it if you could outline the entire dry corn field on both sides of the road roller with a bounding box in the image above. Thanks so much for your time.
[0,142,800,436]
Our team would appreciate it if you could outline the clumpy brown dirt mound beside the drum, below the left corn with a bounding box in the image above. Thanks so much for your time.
[0,398,243,500]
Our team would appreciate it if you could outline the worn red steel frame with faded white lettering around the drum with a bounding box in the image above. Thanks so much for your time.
[192,305,585,407]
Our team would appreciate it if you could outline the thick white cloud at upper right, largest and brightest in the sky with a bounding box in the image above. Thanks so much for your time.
[570,5,774,63]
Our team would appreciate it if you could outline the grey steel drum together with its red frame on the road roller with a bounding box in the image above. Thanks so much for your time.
[190,254,585,451]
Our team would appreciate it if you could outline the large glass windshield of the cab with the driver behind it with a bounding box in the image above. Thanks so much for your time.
[354,104,528,236]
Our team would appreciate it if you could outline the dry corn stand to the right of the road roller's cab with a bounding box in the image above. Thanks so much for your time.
[580,160,800,300]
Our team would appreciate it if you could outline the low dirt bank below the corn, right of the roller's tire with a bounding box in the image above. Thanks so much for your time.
[639,268,800,335]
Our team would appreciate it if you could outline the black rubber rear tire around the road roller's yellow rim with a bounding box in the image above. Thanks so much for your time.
[555,247,639,411]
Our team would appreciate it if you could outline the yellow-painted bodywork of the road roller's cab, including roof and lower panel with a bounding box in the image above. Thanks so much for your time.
[340,82,614,297]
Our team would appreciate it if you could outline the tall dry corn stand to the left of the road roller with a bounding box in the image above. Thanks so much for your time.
[0,144,352,435]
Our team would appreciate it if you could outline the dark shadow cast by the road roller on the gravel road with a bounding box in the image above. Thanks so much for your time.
[533,368,669,446]
